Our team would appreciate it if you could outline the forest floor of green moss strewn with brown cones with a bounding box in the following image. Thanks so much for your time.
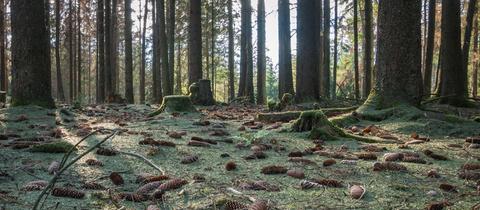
[0,102,480,210]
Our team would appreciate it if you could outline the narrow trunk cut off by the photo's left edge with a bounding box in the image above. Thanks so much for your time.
[0,0,4,103]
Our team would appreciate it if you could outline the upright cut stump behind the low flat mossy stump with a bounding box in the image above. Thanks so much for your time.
[190,79,215,106]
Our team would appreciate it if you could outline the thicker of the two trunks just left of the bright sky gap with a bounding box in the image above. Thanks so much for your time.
[238,0,255,103]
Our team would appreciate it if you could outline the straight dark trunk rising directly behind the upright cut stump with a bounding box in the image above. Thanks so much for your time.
[188,0,202,85]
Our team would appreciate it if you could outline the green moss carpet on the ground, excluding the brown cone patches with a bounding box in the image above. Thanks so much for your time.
[0,105,480,209]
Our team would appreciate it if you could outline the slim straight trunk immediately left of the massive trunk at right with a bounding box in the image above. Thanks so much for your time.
[362,0,376,98]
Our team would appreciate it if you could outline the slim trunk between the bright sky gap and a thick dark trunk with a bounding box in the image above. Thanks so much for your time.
[278,0,294,98]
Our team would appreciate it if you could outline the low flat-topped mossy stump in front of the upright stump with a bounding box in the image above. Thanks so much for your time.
[150,95,197,116]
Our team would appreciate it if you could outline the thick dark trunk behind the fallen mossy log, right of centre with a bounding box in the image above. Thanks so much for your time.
[296,1,320,103]
